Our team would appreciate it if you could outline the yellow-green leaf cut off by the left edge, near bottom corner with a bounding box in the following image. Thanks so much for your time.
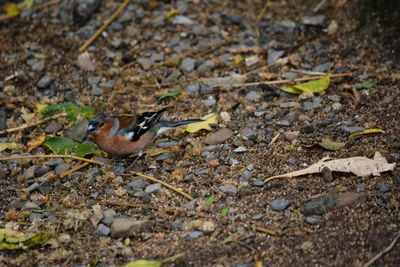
[0,229,51,250]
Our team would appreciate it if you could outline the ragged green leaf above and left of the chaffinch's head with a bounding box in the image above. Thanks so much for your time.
[36,102,94,121]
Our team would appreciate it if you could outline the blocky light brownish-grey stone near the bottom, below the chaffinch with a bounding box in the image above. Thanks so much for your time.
[111,217,155,238]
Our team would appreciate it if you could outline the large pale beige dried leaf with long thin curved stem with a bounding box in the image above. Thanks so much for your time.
[264,152,396,182]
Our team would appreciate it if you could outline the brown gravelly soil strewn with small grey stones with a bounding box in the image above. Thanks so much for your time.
[0,0,400,266]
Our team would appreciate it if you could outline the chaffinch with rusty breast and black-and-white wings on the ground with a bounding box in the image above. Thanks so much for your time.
[87,108,202,156]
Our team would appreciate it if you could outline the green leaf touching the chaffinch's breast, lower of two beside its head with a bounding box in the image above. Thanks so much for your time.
[43,137,102,157]
